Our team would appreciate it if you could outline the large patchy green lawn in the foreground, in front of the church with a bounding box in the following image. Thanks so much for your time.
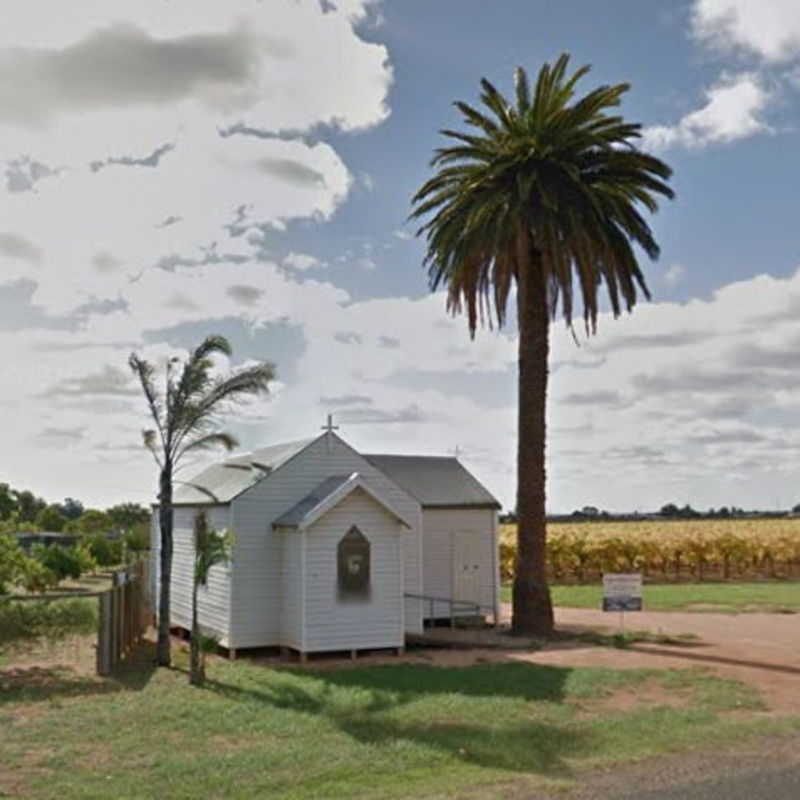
[0,654,800,800]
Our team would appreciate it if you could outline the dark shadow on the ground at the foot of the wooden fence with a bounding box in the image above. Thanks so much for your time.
[0,642,156,705]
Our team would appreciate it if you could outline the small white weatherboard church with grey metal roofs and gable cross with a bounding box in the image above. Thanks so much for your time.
[151,420,500,656]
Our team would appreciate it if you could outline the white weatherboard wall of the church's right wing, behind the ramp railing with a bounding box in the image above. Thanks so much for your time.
[422,508,500,619]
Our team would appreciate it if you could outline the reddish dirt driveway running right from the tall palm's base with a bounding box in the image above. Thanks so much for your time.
[505,608,800,713]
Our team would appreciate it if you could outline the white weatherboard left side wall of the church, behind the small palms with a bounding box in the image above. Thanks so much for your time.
[151,506,235,647]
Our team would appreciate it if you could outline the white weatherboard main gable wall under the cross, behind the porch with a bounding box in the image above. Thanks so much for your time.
[230,434,422,647]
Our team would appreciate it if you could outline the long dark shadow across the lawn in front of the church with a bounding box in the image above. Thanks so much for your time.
[206,664,593,777]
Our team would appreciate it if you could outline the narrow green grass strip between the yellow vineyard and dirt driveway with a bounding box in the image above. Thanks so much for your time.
[501,581,800,612]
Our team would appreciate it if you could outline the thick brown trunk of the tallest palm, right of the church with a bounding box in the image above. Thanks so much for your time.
[511,238,553,636]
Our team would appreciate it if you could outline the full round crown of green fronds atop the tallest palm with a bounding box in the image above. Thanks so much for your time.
[411,55,673,335]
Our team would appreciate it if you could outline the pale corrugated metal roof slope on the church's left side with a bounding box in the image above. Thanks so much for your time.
[173,437,317,505]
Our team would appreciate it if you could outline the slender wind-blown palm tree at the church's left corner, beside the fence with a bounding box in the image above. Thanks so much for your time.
[129,336,275,667]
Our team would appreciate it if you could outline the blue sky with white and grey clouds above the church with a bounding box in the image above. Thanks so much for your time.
[0,0,800,511]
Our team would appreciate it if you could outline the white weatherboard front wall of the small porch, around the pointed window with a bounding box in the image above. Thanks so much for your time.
[302,489,405,653]
